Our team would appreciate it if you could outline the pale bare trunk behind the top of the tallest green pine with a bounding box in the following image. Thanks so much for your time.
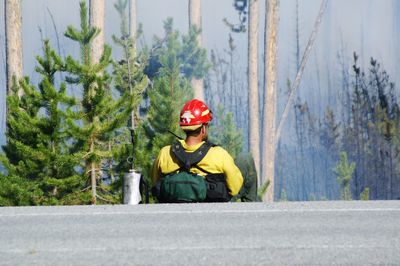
[89,0,104,63]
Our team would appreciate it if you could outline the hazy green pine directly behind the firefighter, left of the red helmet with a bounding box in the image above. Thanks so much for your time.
[137,19,193,181]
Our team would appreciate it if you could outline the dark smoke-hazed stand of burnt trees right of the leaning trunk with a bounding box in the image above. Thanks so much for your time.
[278,51,400,200]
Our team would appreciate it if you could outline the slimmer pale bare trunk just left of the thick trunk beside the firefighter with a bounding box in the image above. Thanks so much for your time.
[247,0,261,184]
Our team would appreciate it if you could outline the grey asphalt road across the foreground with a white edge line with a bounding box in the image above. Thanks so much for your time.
[0,201,400,265]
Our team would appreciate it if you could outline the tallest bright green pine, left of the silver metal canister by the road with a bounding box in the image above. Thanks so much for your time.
[64,1,133,204]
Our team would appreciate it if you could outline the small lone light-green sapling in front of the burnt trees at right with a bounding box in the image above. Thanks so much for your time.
[334,151,356,200]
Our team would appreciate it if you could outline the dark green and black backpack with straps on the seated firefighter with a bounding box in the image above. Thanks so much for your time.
[155,141,231,203]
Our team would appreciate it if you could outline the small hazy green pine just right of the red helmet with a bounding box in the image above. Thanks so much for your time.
[210,105,243,158]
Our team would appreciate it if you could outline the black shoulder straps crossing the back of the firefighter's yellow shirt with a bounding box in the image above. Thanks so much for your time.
[172,141,215,171]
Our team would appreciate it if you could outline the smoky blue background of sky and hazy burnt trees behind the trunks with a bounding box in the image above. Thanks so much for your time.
[0,0,400,205]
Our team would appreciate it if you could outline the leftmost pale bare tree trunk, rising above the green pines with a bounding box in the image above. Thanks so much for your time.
[4,0,23,96]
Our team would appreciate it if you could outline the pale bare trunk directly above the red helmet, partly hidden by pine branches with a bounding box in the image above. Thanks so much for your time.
[189,0,205,101]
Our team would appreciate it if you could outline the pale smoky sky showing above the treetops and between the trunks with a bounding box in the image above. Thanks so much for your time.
[0,0,400,143]
